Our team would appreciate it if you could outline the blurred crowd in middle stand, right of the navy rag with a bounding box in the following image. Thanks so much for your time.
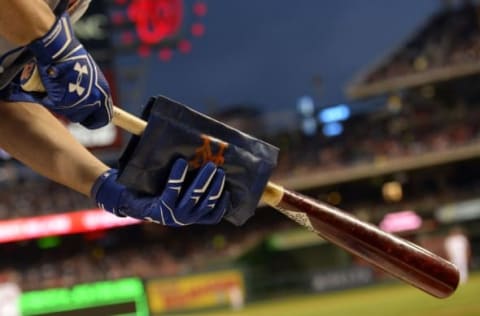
[272,94,480,180]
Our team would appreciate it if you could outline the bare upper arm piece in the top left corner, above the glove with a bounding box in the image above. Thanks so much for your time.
[0,0,55,45]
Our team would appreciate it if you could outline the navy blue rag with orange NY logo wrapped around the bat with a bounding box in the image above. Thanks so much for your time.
[118,96,278,225]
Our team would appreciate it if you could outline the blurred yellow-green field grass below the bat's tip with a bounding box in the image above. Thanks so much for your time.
[208,274,480,316]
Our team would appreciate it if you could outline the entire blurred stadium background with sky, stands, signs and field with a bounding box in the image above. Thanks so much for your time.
[0,0,480,316]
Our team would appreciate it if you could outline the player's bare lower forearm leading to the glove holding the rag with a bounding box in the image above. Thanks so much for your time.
[0,102,108,195]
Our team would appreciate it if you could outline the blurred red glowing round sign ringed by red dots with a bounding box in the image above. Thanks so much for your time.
[111,0,207,61]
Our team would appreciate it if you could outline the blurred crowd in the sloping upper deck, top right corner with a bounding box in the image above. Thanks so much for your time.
[365,1,480,83]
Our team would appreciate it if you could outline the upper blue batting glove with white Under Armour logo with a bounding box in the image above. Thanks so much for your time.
[6,13,113,128]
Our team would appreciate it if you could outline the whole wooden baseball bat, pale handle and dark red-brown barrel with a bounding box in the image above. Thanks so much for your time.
[24,75,459,298]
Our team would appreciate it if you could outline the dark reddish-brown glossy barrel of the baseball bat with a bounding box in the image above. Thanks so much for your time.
[276,189,459,298]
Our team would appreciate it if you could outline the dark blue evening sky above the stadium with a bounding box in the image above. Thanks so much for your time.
[114,0,440,112]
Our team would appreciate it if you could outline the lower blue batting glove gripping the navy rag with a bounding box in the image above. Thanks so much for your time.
[92,159,230,226]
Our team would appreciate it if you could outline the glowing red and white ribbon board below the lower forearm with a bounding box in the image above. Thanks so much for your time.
[0,209,141,243]
